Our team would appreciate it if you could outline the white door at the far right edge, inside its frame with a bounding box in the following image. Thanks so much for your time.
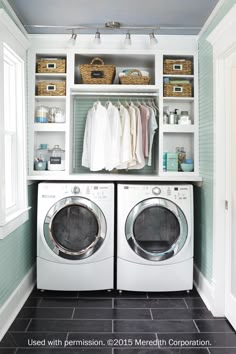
[222,54,236,329]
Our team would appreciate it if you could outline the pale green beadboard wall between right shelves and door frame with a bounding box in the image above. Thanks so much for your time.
[194,0,236,282]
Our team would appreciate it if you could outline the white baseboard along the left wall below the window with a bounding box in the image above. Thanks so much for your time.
[0,265,36,341]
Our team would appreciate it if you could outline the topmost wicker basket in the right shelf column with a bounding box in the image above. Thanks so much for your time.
[163,59,193,75]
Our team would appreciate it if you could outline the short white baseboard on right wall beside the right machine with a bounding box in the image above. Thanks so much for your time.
[193,265,214,312]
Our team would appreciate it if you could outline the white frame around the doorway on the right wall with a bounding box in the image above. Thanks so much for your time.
[207,5,236,316]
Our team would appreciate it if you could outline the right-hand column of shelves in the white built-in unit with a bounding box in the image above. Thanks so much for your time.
[159,51,199,180]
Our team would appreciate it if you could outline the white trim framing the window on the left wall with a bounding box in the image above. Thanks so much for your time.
[0,9,30,240]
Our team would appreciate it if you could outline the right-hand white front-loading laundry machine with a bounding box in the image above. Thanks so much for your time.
[117,184,193,291]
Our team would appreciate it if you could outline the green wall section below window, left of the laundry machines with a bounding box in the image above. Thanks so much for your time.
[0,183,37,306]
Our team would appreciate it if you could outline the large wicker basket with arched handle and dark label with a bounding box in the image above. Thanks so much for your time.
[79,57,116,84]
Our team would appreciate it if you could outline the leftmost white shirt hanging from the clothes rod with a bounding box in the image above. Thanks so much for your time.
[82,101,111,171]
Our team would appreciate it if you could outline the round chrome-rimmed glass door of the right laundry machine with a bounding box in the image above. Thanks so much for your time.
[125,198,188,261]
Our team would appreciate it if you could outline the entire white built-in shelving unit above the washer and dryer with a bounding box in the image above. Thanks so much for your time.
[28,42,201,182]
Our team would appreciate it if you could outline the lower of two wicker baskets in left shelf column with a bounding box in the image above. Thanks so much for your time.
[36,80,66,96]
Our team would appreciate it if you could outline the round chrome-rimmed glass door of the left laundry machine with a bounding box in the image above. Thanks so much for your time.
[44,197,106,260]
